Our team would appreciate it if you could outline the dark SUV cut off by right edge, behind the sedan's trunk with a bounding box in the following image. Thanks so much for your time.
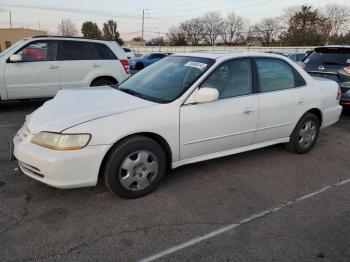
[302,46,350,106]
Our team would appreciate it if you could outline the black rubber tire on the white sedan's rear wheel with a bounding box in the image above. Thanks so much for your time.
[285,113,320,154]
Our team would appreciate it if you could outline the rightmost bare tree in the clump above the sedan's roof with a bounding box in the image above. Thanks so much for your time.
[221,12,247,45]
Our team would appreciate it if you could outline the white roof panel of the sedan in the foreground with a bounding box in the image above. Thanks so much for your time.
[173,51,290,60]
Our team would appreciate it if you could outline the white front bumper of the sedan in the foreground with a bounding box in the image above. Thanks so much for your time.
[13,126,108,188]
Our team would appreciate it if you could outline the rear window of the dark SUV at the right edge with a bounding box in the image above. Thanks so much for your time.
[304,48,350,65]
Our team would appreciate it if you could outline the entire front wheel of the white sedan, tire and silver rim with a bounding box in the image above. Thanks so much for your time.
[104,136,167,198]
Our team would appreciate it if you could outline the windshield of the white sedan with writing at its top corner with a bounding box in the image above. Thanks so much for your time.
[118,56,215,103]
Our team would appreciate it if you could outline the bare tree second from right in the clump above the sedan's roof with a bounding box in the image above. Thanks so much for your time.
[203,12,224,45]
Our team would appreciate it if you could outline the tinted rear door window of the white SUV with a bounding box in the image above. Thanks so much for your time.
[60,41,99,60]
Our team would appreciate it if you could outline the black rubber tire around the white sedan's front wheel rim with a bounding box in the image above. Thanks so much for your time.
[103,136,167,198]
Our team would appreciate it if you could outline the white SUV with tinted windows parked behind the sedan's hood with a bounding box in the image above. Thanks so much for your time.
[0,36,130,100]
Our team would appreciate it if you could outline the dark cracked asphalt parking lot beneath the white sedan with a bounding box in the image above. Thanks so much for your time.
[0,101,350,261]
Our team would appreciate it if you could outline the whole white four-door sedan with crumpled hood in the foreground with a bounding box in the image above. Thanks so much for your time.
[13,53,342,198]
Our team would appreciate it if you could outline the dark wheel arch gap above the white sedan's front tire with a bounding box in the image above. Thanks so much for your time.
[98,132,173,177]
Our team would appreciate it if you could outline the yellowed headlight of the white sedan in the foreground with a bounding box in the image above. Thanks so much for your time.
[31,132,91,150]
